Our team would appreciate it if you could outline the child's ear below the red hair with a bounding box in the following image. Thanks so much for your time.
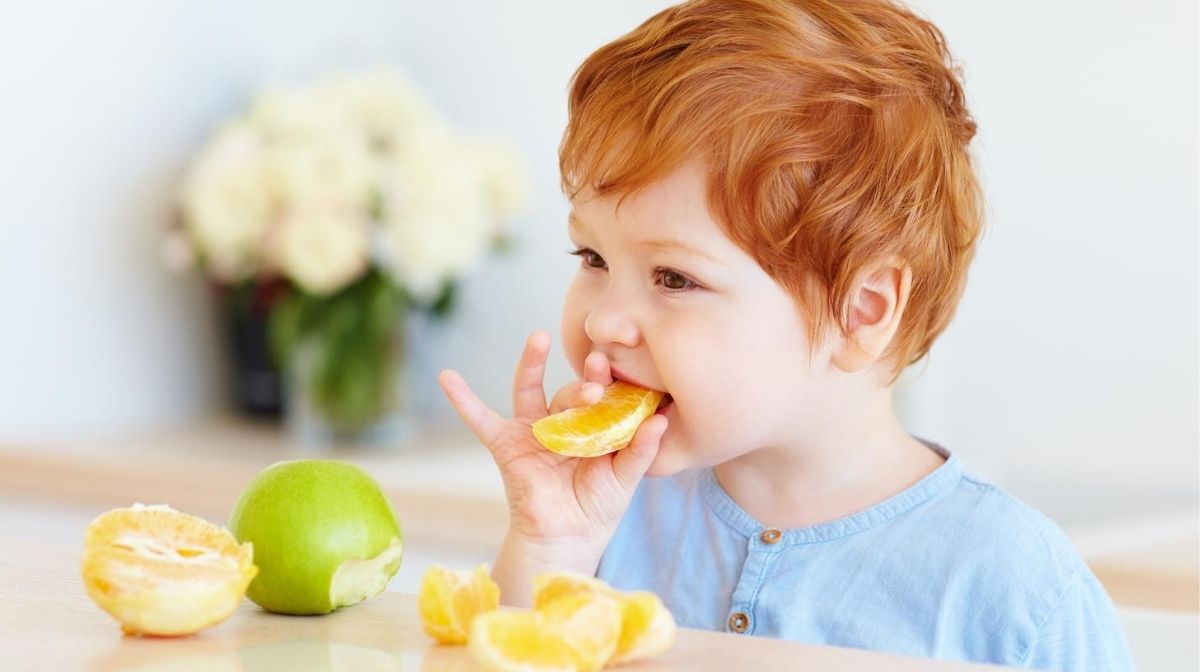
[833,258,912,373]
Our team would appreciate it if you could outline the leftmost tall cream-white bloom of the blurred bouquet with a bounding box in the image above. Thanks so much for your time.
[181,122,275,282]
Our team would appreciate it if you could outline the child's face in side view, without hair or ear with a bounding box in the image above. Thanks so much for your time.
[562,159,829,476]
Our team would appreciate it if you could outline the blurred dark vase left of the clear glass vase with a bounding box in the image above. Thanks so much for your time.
[216,282,284,420]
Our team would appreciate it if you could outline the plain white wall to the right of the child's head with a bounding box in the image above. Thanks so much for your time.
[910,0,1200,506]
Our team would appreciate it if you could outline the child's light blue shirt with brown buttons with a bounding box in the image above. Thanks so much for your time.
[596,445,1133,671]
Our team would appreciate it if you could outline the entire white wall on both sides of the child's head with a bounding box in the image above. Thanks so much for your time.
[0,0,1200,508]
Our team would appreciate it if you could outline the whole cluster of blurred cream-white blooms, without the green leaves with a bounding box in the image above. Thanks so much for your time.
[173,71,528,296]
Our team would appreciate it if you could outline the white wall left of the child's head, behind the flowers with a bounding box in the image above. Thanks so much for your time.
[0,0,664,439]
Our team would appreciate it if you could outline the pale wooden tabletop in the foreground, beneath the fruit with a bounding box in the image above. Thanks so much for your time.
[0,535,995,672]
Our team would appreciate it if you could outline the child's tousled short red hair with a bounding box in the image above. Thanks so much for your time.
[559,0,983,380]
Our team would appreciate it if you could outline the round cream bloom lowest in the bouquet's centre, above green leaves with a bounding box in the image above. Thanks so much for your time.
[272,202,370,294]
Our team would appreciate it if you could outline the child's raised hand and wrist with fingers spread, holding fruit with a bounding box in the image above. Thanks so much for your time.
[438,332,667,606]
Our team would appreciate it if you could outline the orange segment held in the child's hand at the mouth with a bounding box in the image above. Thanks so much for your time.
[533,382,664,457]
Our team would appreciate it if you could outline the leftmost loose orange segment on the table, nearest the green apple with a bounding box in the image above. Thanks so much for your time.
[416,564,500,644]
